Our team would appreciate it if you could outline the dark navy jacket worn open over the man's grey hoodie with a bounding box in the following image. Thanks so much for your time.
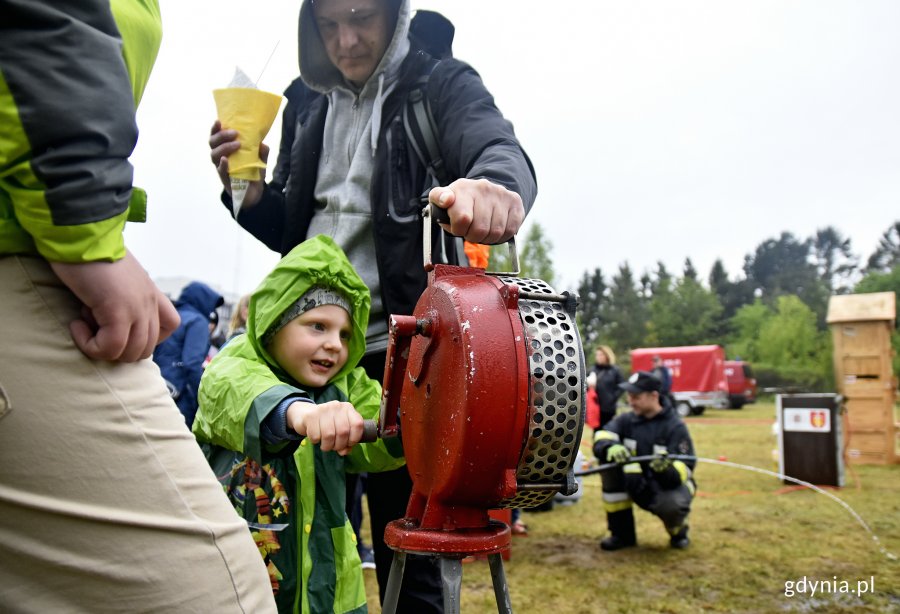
[223,46,537,324]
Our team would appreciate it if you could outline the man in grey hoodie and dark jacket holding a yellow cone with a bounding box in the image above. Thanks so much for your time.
[209,0,537,612]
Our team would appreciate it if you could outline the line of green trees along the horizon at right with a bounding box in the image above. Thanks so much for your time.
[489,221,900,390]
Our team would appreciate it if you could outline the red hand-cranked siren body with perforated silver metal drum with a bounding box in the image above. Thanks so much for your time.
[380,265,585,531]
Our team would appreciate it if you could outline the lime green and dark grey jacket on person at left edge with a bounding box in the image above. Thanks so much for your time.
[0,0,162,263]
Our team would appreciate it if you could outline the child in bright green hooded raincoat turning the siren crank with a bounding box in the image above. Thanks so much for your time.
[199,235,404,613]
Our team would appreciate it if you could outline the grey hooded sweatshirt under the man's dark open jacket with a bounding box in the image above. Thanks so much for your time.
[300,0,410,352]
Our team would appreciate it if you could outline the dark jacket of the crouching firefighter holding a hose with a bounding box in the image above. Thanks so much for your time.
[594,399,697,489]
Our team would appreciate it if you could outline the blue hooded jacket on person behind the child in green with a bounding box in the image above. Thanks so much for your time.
[153,281,223,427]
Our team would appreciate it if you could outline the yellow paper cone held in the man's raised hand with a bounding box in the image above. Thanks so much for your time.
[213,87,281,181]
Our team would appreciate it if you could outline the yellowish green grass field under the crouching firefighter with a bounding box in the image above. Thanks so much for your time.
[366,403,900,614]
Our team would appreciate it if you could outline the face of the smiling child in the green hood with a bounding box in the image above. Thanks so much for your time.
[269,305,351,388]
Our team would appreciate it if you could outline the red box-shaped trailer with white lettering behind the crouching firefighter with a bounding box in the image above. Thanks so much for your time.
[631,345,728,416]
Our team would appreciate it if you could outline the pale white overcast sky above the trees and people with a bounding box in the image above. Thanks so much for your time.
[126,0,900,295]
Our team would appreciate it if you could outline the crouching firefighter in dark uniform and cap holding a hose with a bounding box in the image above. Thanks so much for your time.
[594,371,696,550]
